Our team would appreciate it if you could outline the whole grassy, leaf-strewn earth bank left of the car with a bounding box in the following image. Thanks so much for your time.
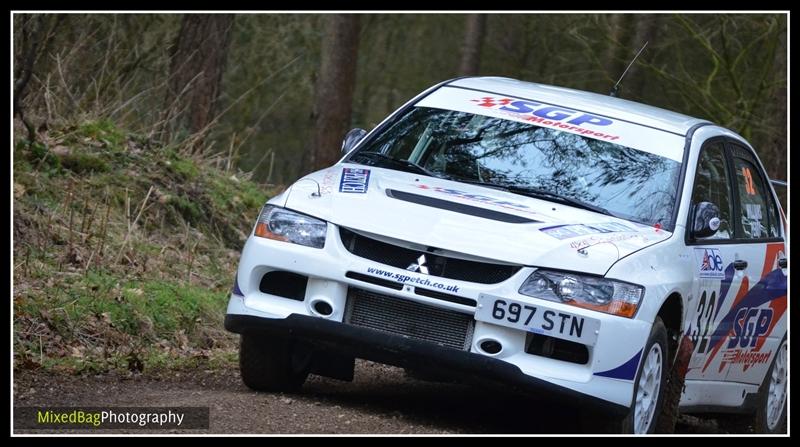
[13,121,276,373]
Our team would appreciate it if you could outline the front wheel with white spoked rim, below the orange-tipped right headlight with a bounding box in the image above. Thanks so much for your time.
[614,317,671,434]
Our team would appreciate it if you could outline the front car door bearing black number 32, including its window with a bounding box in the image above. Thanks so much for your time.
[686,138,745,380]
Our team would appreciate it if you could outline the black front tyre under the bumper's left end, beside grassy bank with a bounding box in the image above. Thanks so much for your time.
[239,334,308,391]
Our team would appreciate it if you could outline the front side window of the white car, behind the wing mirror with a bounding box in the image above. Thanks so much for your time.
[692,143,733,240]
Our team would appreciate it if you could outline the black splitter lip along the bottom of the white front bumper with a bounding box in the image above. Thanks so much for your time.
[225,314,628,415]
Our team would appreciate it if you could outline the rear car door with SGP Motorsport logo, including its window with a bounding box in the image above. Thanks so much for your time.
[719,141,787,384]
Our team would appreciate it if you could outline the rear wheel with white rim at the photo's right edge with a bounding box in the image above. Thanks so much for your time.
[753,336,789,434]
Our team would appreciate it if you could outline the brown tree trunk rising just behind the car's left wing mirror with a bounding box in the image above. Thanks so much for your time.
[307,14,359,170]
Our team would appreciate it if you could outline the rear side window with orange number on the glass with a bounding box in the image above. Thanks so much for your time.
[733,146,780,239]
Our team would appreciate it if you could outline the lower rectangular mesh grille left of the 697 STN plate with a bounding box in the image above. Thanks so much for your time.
[344,287,475,351]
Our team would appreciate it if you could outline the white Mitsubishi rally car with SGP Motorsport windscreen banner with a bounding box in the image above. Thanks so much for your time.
[225,77,788,433]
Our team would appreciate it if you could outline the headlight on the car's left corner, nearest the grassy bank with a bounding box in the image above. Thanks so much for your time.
[255,205,328,248]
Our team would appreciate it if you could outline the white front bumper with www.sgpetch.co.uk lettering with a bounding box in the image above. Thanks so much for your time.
[227,228,651,407]
